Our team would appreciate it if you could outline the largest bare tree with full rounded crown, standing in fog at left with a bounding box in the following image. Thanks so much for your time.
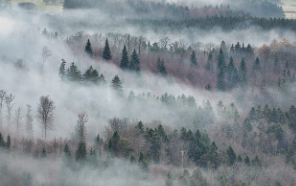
[37,96,55,140]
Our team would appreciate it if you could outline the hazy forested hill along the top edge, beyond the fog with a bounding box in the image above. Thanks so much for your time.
[64,0,284,19]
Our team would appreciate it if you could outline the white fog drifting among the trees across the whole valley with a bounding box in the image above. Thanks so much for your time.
[0,0,296,186]
